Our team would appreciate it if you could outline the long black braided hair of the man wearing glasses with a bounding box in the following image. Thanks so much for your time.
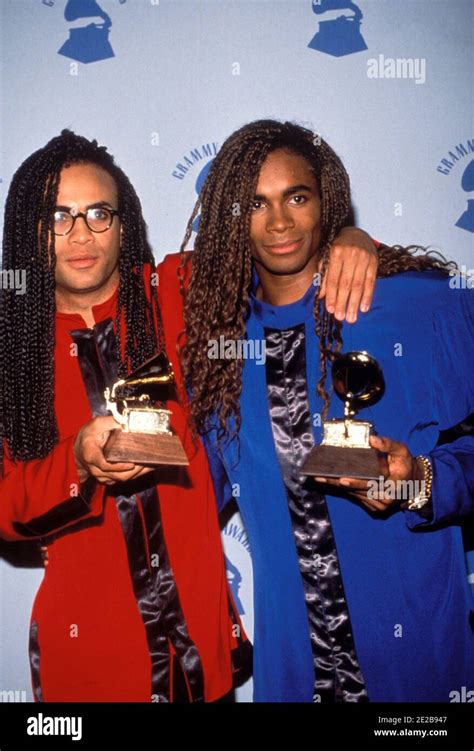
[0,130,164,470]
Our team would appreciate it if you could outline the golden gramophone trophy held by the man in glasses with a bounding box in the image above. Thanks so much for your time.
[104,352,189,466]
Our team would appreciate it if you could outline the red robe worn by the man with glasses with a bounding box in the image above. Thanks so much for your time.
[0,256,249,702]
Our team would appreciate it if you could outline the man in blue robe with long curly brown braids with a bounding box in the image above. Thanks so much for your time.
[182,120,474,702]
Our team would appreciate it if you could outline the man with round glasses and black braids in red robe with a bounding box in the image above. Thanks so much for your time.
[0,131,374,702]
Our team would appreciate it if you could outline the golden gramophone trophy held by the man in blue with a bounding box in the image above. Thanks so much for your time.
[300,352,385,480]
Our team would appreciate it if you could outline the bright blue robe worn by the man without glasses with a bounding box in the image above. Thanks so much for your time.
[204,272,474,702]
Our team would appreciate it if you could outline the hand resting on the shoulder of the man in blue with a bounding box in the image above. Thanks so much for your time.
[319,227,378,323]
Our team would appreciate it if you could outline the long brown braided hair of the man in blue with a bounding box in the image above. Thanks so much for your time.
[179,120,455,440]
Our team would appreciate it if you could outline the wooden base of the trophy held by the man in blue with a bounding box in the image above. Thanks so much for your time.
[300,444,383,480]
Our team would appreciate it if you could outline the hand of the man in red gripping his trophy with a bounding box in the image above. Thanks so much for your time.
[74,416,155,485]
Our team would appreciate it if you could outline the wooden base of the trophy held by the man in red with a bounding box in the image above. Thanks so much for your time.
[104,430,189,467]
